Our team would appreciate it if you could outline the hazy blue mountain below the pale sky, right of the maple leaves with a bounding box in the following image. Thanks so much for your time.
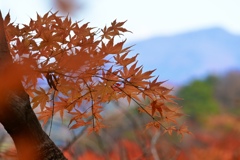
[128,28,240,85]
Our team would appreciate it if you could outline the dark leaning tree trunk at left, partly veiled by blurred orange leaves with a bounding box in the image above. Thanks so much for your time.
[0,12,66,160]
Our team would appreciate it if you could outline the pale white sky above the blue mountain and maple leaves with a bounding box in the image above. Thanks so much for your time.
[0,0,240,41]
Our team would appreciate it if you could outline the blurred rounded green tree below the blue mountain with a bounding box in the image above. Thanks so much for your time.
[177,76,220,121]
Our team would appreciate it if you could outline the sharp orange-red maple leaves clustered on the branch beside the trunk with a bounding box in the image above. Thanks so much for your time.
[5,12,190,134]
